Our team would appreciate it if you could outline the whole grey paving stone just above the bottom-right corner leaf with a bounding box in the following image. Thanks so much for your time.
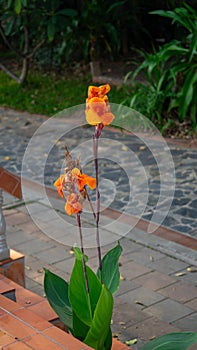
[146,299,193,323]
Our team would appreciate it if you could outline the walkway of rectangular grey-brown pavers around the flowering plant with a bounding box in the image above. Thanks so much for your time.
[4,191,197,350]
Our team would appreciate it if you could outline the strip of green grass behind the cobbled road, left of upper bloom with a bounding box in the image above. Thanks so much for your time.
[0,71,125,116]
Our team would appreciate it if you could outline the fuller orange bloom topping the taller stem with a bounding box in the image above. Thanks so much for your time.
[86,84,114,125]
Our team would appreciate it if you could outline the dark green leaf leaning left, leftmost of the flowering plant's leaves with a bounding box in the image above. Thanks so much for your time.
[44,269,73,330]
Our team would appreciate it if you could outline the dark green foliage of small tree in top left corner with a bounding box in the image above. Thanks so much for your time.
[0,0,77,83]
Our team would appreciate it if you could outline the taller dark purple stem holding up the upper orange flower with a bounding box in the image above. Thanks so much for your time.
[92,132,102,273]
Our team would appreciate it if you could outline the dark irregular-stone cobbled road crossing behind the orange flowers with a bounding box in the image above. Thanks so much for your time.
[0,108,197,237]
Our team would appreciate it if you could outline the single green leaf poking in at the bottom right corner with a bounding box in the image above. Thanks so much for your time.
[141,332,197,350]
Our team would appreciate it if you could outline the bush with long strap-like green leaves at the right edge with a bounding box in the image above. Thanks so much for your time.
[125,4,197,133]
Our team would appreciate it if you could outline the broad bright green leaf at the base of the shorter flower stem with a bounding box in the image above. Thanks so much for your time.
[68,259,101,326]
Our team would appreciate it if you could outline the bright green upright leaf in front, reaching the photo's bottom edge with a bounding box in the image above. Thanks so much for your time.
[84,284,113,350]
